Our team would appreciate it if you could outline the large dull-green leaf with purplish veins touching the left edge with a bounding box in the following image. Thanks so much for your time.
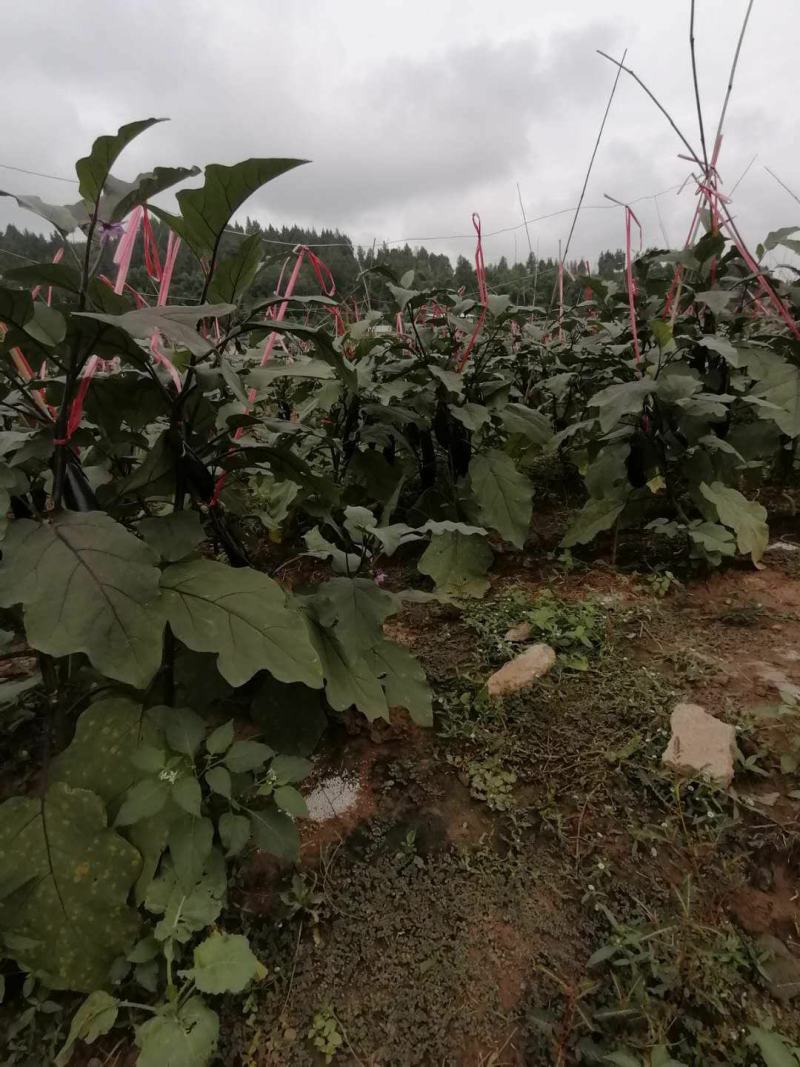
[0,511,163,688]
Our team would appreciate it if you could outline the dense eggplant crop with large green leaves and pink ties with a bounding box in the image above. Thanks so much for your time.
[0,120,800,1067]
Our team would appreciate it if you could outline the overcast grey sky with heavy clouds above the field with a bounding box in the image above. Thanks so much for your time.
[0,0,800,260]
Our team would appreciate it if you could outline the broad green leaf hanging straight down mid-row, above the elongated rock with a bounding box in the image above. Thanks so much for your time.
[469,448,533,548]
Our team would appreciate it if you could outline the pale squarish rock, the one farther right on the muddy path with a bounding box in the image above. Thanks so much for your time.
[661,704,736,787]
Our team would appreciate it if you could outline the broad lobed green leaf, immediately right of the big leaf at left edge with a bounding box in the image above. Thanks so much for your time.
[161,559,322,688]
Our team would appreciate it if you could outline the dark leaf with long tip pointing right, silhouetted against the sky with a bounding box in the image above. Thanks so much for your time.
[158,159,307,256]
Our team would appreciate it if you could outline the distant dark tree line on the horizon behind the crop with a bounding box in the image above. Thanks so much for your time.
[0,217,625,309]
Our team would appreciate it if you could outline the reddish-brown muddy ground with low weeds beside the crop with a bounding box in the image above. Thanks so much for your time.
[222,535,800,1067]
